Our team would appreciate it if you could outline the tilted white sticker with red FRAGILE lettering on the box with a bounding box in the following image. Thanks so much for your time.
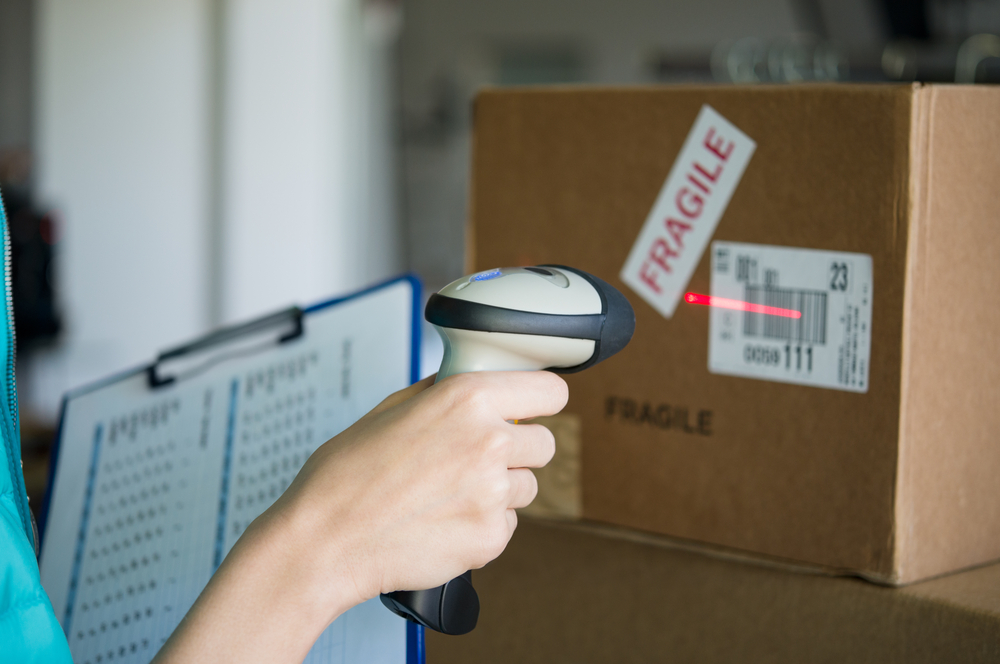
[620,105,757,318]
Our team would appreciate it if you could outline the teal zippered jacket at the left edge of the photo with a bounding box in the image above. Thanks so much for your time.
[0,188,73,664]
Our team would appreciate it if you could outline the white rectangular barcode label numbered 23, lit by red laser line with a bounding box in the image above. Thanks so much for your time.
[704,242,872,392]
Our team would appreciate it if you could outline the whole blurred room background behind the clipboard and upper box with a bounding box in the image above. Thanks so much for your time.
[0,0,1000,505]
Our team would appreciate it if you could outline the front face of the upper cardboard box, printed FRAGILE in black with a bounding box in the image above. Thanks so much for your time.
[471,81,1000,582]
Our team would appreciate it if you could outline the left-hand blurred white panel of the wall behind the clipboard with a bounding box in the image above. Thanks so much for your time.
[32,0,208,411]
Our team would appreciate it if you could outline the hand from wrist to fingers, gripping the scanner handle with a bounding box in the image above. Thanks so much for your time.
[275,372,567,601]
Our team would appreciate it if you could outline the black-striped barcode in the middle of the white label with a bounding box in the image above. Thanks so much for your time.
[743,284,827,345]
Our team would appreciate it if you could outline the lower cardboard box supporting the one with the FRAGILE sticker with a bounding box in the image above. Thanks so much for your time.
[427,519,1000,664]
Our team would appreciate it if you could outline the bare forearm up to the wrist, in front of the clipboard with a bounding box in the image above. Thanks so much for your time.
[153,505,362,664]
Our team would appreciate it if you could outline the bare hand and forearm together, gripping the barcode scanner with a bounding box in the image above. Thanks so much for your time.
[155,372,567,664]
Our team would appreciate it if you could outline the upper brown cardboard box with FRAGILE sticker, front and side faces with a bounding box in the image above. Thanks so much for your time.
[470,85,1000,584]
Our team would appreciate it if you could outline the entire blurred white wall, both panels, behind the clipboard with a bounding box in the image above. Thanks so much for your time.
[28,0,401,417]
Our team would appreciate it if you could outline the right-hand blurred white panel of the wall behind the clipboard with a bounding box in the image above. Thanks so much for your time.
[222,0,403,321]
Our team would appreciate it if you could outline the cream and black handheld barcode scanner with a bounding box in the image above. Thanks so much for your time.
[382,265,635,634]
